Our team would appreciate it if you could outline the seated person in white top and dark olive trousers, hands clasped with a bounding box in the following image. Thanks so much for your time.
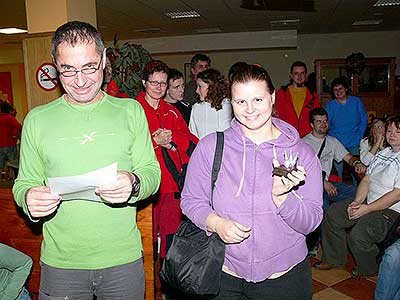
[315,117,400,277]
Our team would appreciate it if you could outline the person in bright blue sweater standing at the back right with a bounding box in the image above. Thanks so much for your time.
[325,77,368,185]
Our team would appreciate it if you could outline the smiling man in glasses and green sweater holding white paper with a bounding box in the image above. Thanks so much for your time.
[13,21,161,300]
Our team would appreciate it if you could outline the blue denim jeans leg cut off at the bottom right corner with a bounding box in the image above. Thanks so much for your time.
[375,239,400,300]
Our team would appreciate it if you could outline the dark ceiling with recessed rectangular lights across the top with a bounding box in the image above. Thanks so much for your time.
[0,0,400,44]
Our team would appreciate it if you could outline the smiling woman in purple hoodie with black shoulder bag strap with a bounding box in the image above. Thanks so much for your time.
[181,65,322,300]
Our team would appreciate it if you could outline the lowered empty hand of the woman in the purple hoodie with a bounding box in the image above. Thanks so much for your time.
[207,214,251,244]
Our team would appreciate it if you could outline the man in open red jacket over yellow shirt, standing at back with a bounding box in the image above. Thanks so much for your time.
[275,61,321,137]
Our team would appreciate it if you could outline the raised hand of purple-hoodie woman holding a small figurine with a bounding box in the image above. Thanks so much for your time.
[272,159,306,207]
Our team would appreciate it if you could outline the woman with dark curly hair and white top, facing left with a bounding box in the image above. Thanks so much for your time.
[189,69,232,139]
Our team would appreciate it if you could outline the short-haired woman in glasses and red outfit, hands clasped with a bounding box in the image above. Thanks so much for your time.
[136,60,197,292]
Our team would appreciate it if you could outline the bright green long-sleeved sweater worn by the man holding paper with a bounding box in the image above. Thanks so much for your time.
[13,95,161,269]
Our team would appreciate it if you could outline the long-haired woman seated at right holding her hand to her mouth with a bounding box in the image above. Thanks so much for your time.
[360,117,388,166]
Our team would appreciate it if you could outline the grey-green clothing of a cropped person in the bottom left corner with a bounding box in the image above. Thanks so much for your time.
[0,243,32,300]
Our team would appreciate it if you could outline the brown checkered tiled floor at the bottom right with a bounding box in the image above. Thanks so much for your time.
[311,258,376,300]
